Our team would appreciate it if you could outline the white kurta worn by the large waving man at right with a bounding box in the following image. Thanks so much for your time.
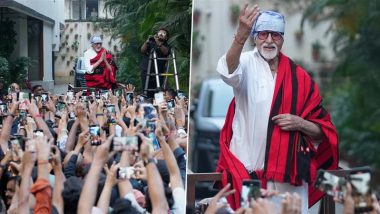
[217,48,308,213]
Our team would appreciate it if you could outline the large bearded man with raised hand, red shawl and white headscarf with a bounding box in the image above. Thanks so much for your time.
[217,5,338,213]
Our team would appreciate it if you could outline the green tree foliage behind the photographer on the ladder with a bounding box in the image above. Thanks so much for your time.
[102,0,192,91]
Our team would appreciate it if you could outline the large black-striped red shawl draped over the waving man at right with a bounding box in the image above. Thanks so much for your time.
[216,53,339,209]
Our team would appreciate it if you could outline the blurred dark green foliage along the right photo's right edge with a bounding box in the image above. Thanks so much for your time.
[303,0,380,169]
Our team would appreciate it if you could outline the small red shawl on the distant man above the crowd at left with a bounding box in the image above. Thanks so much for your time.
[84,48,117,89]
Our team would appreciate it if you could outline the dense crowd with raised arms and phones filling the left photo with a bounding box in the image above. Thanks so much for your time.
[0,81,188,214]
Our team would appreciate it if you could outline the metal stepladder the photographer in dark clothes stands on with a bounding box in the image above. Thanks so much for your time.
[144,49,179,95]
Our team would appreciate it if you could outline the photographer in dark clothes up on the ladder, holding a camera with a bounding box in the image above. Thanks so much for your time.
[140,28,170,98]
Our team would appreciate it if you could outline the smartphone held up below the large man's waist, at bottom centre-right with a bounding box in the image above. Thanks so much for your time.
[240,180,261,207]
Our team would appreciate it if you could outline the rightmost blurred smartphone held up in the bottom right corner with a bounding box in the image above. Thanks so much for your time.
[348,168,373,213]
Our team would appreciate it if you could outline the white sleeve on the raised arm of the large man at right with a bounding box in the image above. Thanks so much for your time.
[216,55,243,89]
